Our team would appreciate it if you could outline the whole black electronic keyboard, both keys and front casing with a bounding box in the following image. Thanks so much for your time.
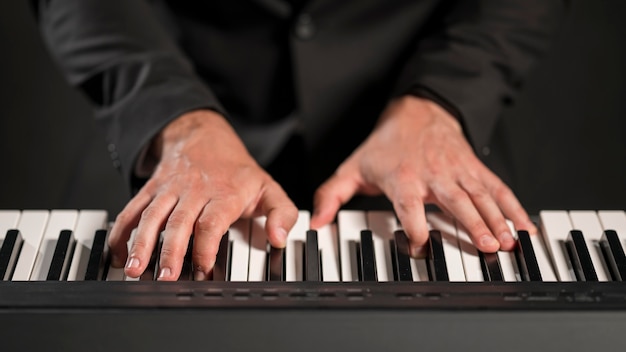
[0,210,626,351]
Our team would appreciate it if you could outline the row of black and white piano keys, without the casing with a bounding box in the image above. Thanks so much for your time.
[0,210,626,282]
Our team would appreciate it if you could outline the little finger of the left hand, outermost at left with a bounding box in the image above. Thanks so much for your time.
[108,192,152,268]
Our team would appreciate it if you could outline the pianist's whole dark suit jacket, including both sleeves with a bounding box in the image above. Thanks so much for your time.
[35,0,564,192]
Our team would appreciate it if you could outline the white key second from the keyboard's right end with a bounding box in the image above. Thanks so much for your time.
[569,211,610,281]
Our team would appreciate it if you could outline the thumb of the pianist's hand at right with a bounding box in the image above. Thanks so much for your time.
[311,173,359,229]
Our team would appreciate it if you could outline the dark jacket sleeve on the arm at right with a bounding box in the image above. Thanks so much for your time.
[396,0,566,149]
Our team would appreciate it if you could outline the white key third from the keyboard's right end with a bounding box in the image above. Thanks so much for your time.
[533,210,576,281]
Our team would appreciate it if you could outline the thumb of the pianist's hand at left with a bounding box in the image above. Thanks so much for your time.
[259,182,298,248]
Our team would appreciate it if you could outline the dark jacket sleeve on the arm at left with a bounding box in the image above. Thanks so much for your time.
[33,0,223,191]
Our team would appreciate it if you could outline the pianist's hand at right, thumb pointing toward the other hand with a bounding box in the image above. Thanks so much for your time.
[311,96,536,256]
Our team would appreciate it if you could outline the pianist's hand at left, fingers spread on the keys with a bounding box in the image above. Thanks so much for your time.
[109,110,298,280]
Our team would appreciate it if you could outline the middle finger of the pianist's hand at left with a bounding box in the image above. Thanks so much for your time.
[157,196,204,281]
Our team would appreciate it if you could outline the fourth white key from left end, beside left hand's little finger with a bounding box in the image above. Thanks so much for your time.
[67,210,108,281]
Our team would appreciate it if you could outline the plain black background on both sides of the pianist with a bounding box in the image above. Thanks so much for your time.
[0,0,626,217]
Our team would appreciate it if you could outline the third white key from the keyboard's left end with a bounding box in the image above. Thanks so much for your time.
[30,210,78,281]
